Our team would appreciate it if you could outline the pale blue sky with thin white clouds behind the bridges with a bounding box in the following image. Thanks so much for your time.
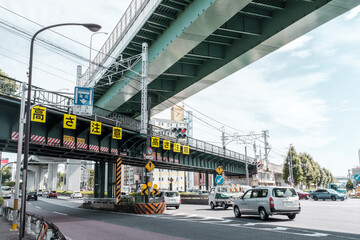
[0,0,360,175]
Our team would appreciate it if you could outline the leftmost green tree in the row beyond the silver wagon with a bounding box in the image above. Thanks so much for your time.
[282,146,303,185]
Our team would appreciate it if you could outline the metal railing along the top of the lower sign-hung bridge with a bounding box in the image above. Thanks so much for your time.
[0,75,255,164]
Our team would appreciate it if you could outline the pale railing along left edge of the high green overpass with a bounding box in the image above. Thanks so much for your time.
[81,0,149,86]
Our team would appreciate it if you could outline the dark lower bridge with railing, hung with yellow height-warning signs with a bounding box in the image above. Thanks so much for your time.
[0,76,256,176]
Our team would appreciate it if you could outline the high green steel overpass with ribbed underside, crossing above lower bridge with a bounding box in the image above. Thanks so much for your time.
[82,0,360,117]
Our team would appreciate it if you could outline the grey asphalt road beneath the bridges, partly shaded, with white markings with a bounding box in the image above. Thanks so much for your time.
[5,197,360,240]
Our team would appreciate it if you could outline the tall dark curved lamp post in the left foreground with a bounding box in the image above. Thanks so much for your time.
[20,23,101,239]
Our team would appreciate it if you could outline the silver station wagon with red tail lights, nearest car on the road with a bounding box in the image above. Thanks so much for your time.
[234,186,301,220]
